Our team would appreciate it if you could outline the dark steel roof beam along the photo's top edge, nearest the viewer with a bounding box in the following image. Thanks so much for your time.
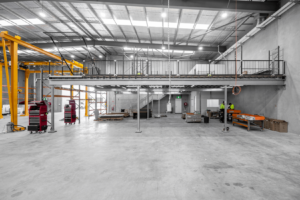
[0,0,279,13]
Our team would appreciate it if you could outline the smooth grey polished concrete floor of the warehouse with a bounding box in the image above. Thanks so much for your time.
[0,113,300,200]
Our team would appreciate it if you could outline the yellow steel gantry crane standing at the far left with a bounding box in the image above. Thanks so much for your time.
[0,31,83,131]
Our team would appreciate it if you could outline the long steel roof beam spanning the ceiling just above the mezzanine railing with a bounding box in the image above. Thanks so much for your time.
[34,41,226,52]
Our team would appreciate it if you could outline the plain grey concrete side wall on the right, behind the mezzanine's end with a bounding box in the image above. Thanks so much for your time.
[228,4,300,133]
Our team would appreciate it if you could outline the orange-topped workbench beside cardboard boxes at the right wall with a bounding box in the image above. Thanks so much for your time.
[232,114,265,131]
